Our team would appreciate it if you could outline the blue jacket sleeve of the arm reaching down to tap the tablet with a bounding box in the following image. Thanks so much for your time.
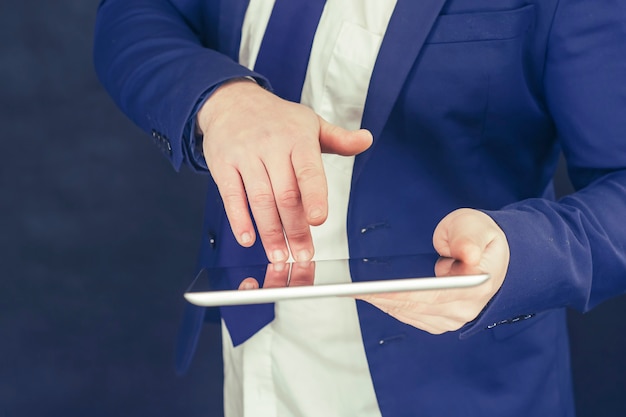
[94,0,266,170]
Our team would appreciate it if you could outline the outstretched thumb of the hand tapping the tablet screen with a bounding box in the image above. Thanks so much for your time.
[319,117,373,156]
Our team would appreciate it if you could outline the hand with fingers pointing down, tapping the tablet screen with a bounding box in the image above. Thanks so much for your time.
[198,80,372,262]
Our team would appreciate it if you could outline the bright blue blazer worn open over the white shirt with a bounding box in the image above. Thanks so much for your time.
[95,0,626,416]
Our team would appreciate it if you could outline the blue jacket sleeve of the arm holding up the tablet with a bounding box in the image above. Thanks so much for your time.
[464,0,626,336]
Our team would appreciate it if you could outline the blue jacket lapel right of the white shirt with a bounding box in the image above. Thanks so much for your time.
[353,0,445,179]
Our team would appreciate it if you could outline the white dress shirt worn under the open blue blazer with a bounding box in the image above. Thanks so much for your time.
[222,0,396,417]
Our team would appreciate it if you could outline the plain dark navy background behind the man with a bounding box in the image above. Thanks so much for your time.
[0,0,626,417]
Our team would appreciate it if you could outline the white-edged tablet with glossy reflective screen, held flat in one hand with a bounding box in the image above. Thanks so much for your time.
[185,254,489,307]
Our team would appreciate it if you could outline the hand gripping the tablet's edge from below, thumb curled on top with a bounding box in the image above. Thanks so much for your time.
[358,209,510,334]
